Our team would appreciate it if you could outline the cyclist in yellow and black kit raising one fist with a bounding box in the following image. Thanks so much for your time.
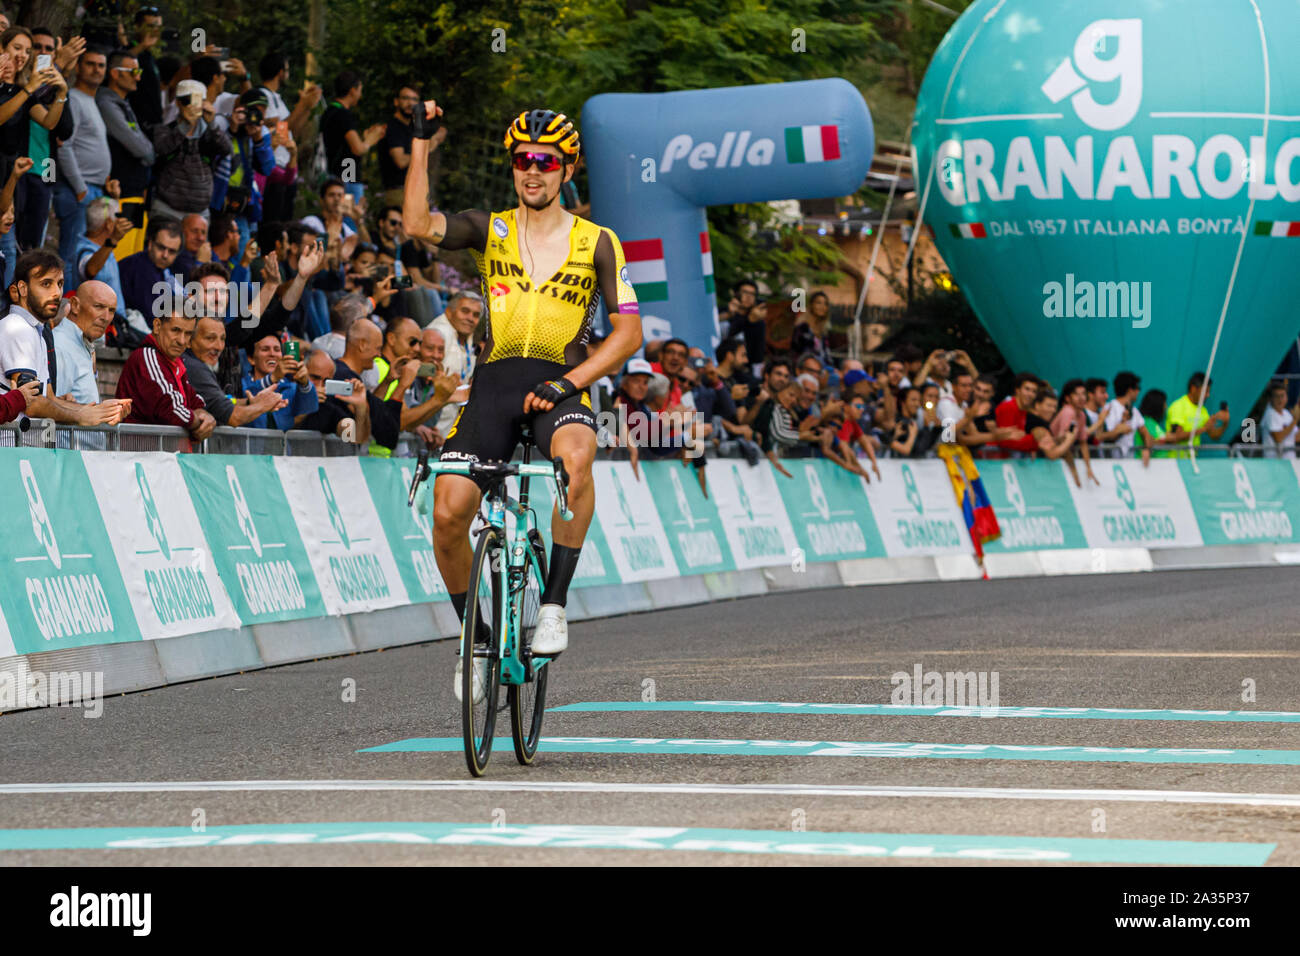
[402,100,641,697]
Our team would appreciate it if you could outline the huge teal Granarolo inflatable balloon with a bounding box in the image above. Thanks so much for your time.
[913,0,1300,418]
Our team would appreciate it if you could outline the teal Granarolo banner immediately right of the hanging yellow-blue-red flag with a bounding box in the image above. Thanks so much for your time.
[976,460,1101,554]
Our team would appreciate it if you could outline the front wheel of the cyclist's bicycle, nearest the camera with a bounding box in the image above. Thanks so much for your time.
[460,527,504,777]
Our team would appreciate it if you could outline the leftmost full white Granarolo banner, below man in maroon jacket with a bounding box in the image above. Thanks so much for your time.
[83,451,239,640]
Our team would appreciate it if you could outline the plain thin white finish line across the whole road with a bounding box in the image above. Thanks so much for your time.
[0,780,1300,806]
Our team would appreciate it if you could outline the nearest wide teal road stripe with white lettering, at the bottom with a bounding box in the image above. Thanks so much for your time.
[0,821,1277,866]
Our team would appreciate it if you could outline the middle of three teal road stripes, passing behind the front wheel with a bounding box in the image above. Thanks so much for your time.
[359,737,1300,766]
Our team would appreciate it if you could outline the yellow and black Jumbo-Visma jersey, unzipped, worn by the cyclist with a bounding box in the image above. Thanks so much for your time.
[471,209,638,367]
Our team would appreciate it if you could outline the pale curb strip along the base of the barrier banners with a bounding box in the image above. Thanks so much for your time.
[0,545,1300,711]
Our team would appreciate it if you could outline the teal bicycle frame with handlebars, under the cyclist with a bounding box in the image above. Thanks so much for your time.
[411,444,573,684]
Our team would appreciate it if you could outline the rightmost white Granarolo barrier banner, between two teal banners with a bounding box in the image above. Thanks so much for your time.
[1062,458,1203,548]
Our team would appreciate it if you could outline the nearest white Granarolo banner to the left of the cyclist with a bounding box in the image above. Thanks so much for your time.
[274,458,410,614]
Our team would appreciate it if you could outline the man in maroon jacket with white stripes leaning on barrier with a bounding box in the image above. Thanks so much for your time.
[117,311,217,441]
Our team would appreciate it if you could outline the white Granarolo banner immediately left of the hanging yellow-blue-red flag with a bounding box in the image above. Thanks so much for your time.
[867,459,974,558]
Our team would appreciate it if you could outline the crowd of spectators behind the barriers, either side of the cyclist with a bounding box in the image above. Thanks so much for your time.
[0,7,1300,484]
